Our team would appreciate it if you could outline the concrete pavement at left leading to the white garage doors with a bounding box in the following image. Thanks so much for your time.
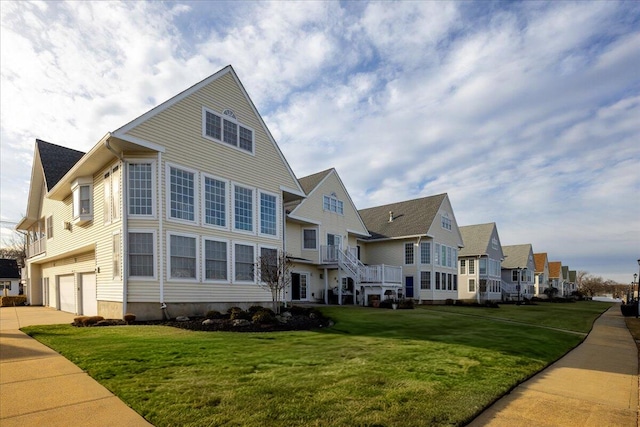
[0,307,151,427]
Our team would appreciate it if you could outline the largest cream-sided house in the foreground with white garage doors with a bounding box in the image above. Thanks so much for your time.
[17,66,305,319]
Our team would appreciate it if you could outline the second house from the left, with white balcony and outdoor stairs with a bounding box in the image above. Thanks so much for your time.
[285,169,402,304]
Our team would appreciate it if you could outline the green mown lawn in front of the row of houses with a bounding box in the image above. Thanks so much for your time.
[23,302,610,426]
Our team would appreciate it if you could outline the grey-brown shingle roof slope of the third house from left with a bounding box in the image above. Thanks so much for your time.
[358,193,447,240]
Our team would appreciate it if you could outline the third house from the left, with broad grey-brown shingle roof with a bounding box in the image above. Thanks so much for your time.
[359,194,462,303]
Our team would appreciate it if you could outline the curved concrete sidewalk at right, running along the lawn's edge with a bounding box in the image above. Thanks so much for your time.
[469,304,638,427]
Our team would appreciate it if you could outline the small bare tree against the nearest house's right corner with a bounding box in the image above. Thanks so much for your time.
[257,248,293,313]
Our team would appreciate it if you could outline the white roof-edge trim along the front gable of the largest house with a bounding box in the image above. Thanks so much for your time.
[112,65,305,201]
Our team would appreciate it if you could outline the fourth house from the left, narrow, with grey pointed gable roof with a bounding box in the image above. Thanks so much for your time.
[458,222,504,302]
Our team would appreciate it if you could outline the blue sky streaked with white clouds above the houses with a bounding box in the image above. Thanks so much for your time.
[0,1,640,283]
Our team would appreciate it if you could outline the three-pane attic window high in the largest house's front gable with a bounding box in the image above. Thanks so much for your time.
[202,108,254,154]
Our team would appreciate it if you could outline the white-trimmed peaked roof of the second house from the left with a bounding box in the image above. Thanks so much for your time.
[289,168,369,237]
